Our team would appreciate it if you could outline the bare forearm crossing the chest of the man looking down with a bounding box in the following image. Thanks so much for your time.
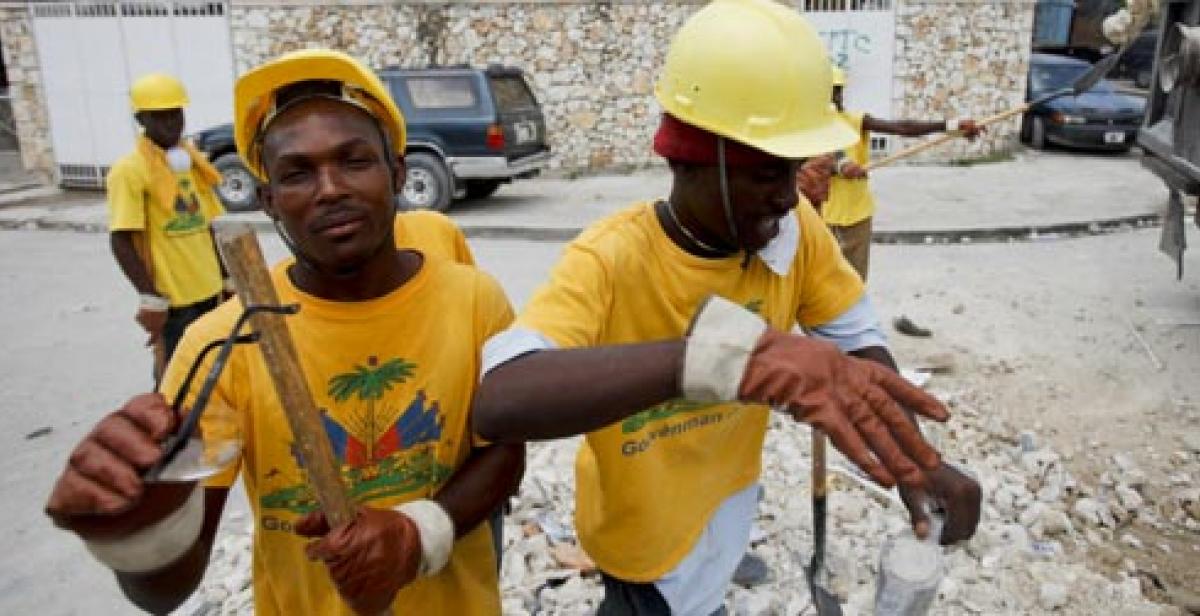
[473,340,684,443]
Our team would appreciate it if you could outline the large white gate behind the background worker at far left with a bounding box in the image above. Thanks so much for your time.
[30,1,234,186]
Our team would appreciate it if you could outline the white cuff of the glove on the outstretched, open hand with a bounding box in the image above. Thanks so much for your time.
[680,295,767,402]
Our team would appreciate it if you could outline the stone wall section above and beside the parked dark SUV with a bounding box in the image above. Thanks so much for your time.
[232,1,703,171]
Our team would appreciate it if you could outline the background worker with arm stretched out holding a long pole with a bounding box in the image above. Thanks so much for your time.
[825,66,983,281]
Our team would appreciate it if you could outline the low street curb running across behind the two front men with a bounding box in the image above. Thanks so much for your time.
[0,208,1160,244]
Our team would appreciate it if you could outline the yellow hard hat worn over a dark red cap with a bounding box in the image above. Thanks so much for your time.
[654,0,858,159]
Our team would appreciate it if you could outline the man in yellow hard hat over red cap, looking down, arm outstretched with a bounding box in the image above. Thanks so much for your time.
[474,0,979,615]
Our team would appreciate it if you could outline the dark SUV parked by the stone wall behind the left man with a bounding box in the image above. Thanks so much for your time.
[192,66,550,211]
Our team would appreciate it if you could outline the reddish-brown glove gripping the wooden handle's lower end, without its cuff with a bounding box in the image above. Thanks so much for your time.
[295,507,421,616]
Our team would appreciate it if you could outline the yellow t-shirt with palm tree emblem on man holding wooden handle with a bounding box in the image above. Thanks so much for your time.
[163,253,512,609]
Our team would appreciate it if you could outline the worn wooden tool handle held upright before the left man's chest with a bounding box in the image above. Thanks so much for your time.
[216,223,354,528]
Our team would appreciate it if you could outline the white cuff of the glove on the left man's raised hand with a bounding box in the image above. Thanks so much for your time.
[83,485,204,573]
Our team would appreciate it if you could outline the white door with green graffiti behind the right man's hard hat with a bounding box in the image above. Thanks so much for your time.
[797,0,896,154]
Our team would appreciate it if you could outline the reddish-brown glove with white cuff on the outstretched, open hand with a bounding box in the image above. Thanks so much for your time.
[682,297,949,488]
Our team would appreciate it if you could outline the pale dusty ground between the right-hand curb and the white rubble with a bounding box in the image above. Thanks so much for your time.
[871,228,1200,609]
